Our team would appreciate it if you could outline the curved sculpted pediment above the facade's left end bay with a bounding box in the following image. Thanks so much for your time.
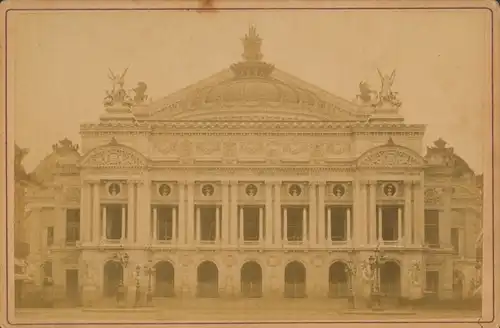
[80,141,147,168]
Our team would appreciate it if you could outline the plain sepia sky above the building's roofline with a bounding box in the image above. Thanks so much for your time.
[7,10,491,172]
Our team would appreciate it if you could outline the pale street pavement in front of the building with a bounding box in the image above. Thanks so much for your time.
[12,299,480,323]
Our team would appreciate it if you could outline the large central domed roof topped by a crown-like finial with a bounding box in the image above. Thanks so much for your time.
[145,27,368,121]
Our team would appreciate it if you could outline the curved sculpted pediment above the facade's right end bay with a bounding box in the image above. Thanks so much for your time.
[357,140,425,168]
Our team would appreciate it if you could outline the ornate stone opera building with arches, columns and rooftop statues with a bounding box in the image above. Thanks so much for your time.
[21,28,482,302]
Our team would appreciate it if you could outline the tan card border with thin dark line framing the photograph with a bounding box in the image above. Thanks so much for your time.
[2,1,498,326]
